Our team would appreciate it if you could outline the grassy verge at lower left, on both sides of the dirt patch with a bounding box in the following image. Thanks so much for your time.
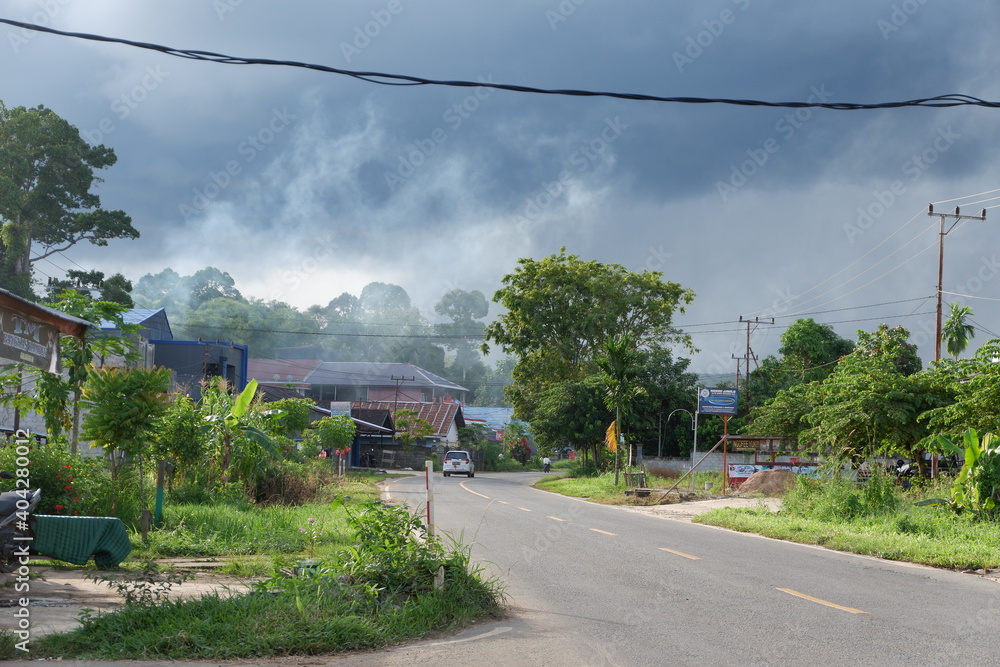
[0,472,503,660]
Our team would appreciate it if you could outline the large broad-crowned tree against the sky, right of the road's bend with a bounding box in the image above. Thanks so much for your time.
[482,248,694,421]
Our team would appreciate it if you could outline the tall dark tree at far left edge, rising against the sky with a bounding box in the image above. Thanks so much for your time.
[0,102,139,299]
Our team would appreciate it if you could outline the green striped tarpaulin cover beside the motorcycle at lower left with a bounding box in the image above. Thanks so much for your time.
[31,514,132,567]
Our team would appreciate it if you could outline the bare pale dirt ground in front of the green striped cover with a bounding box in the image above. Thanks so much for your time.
[0,561,249,637]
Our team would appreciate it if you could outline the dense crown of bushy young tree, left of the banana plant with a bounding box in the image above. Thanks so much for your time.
[82,366,170,478]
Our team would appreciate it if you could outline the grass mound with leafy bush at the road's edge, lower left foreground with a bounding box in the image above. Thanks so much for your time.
[32,494,502,662]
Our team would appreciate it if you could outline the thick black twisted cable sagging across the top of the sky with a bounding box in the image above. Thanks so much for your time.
[0,18,1000,111]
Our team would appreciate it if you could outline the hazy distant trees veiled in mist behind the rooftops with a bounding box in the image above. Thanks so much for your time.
[132,267,489,402]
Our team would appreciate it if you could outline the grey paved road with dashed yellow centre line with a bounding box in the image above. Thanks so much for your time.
[330,473,1000,667]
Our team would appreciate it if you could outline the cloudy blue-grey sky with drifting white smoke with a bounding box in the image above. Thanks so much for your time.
[0,0,1000,374]
